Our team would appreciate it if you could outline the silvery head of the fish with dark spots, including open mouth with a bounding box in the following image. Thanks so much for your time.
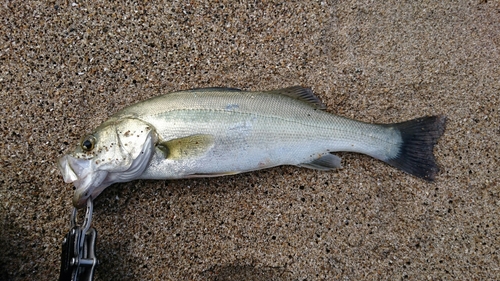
[59,118,157,208]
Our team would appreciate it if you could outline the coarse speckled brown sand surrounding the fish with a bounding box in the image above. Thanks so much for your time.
[0,0,500,280]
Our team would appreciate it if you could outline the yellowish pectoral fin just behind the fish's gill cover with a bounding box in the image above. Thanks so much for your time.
[156,134,214,160]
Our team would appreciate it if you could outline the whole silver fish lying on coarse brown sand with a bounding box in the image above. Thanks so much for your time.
[59,86,446,207]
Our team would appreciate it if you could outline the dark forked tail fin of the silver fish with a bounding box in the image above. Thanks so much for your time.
[385,115,446,181]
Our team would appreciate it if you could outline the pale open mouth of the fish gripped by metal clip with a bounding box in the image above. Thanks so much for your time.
[58,155,109,208]
